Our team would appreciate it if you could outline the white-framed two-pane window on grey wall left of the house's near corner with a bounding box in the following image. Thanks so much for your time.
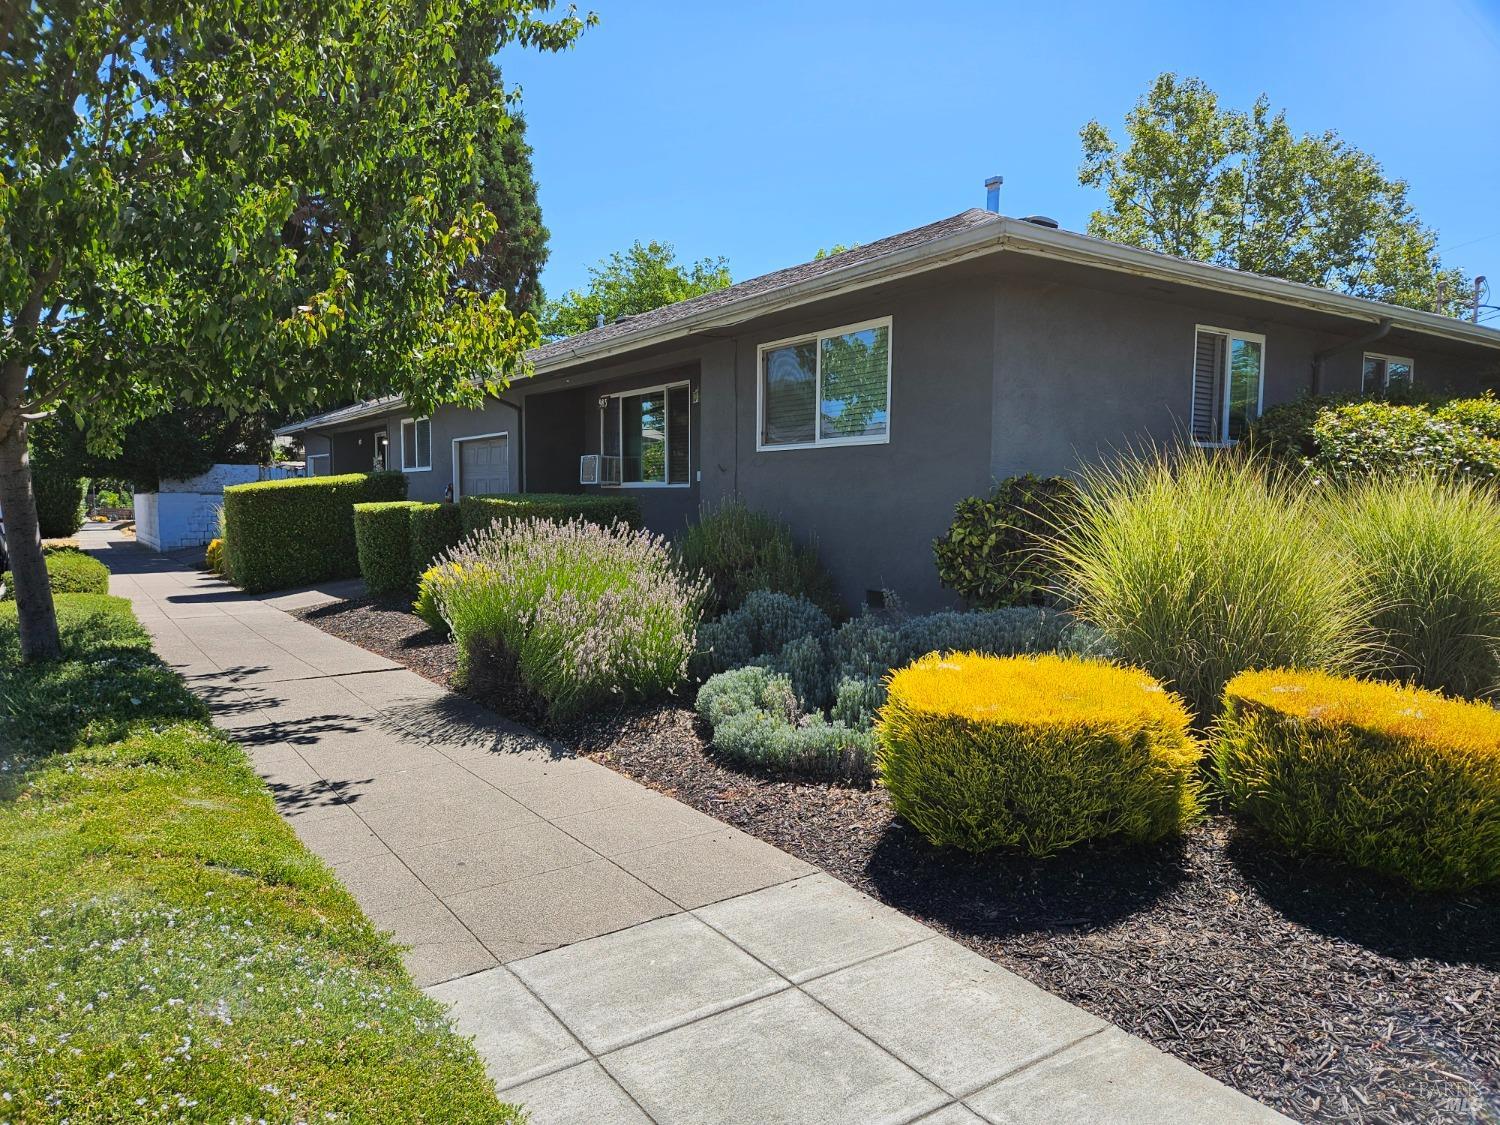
[756,317,891,450]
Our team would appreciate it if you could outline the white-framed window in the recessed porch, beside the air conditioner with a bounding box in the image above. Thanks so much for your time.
[599,383,693,488]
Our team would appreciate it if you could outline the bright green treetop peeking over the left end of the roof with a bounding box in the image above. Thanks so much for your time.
[540,242,732,339]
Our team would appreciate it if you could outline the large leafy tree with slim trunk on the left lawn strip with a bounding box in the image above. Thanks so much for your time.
[0,0,588,659]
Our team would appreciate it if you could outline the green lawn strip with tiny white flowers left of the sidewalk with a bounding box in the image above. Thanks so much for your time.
[0,594,524,1122]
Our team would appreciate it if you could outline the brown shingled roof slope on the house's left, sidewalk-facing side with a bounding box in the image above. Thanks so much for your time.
[528,207,1001,368]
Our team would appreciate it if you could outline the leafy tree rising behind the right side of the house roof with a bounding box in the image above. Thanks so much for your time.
[1079,74,1469,315]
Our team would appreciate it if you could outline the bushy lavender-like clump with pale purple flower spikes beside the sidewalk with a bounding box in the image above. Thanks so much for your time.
[437,519,708,720]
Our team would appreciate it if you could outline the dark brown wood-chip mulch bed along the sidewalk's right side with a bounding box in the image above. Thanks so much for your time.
[295,603,1500,1122]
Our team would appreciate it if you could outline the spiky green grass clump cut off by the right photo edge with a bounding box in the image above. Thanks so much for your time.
[1325,474,1500,698]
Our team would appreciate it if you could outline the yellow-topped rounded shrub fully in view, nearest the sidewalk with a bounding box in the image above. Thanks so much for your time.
[876,653,1203,855]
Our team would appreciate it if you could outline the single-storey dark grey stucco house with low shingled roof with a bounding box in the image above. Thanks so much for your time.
[282,210,1500,608]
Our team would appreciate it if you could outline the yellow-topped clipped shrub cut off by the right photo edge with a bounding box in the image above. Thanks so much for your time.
[1214,671,1500,890]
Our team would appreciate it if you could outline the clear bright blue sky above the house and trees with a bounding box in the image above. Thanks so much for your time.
[501,0,1500,309]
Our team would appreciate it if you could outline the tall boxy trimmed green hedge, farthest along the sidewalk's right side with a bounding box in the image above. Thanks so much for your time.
[224,473,407,594]
